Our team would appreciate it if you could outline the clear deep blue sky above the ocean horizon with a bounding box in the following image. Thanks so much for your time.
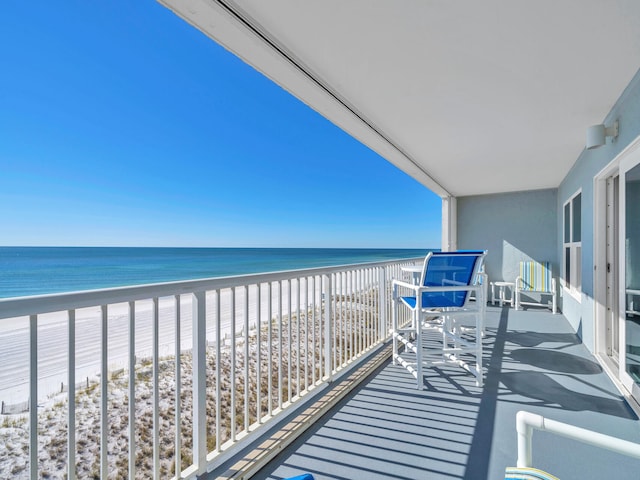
[0,0,441,248]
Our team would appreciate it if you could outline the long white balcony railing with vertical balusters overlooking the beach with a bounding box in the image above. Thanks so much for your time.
[0,259,418,480]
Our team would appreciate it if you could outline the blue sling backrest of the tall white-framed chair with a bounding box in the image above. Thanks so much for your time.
[420,250,487,307]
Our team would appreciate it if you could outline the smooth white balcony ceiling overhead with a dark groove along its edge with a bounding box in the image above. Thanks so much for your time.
[160,0,640,196]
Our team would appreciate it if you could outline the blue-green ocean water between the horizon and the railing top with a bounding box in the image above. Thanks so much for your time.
[0,247,429,298]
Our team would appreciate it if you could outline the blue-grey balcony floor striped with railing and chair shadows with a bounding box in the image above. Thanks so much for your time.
[253,307,640,480]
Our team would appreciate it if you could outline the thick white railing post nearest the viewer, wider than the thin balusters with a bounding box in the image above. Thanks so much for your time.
[192,292,206,475]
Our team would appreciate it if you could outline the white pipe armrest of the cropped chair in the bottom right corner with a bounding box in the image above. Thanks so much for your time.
[516,411,640,467]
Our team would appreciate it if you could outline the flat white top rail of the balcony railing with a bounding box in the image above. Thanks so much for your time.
[0,257,423,320]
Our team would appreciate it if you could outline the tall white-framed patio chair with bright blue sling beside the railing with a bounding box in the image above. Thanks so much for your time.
[392,250,487,389]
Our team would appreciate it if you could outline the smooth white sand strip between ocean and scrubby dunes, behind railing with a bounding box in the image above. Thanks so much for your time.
[0,280,320,404]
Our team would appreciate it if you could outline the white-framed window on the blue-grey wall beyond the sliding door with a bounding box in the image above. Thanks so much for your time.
[563,192,582,295]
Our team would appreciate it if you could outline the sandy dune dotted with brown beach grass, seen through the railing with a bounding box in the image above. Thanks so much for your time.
[0,296,377,479]
